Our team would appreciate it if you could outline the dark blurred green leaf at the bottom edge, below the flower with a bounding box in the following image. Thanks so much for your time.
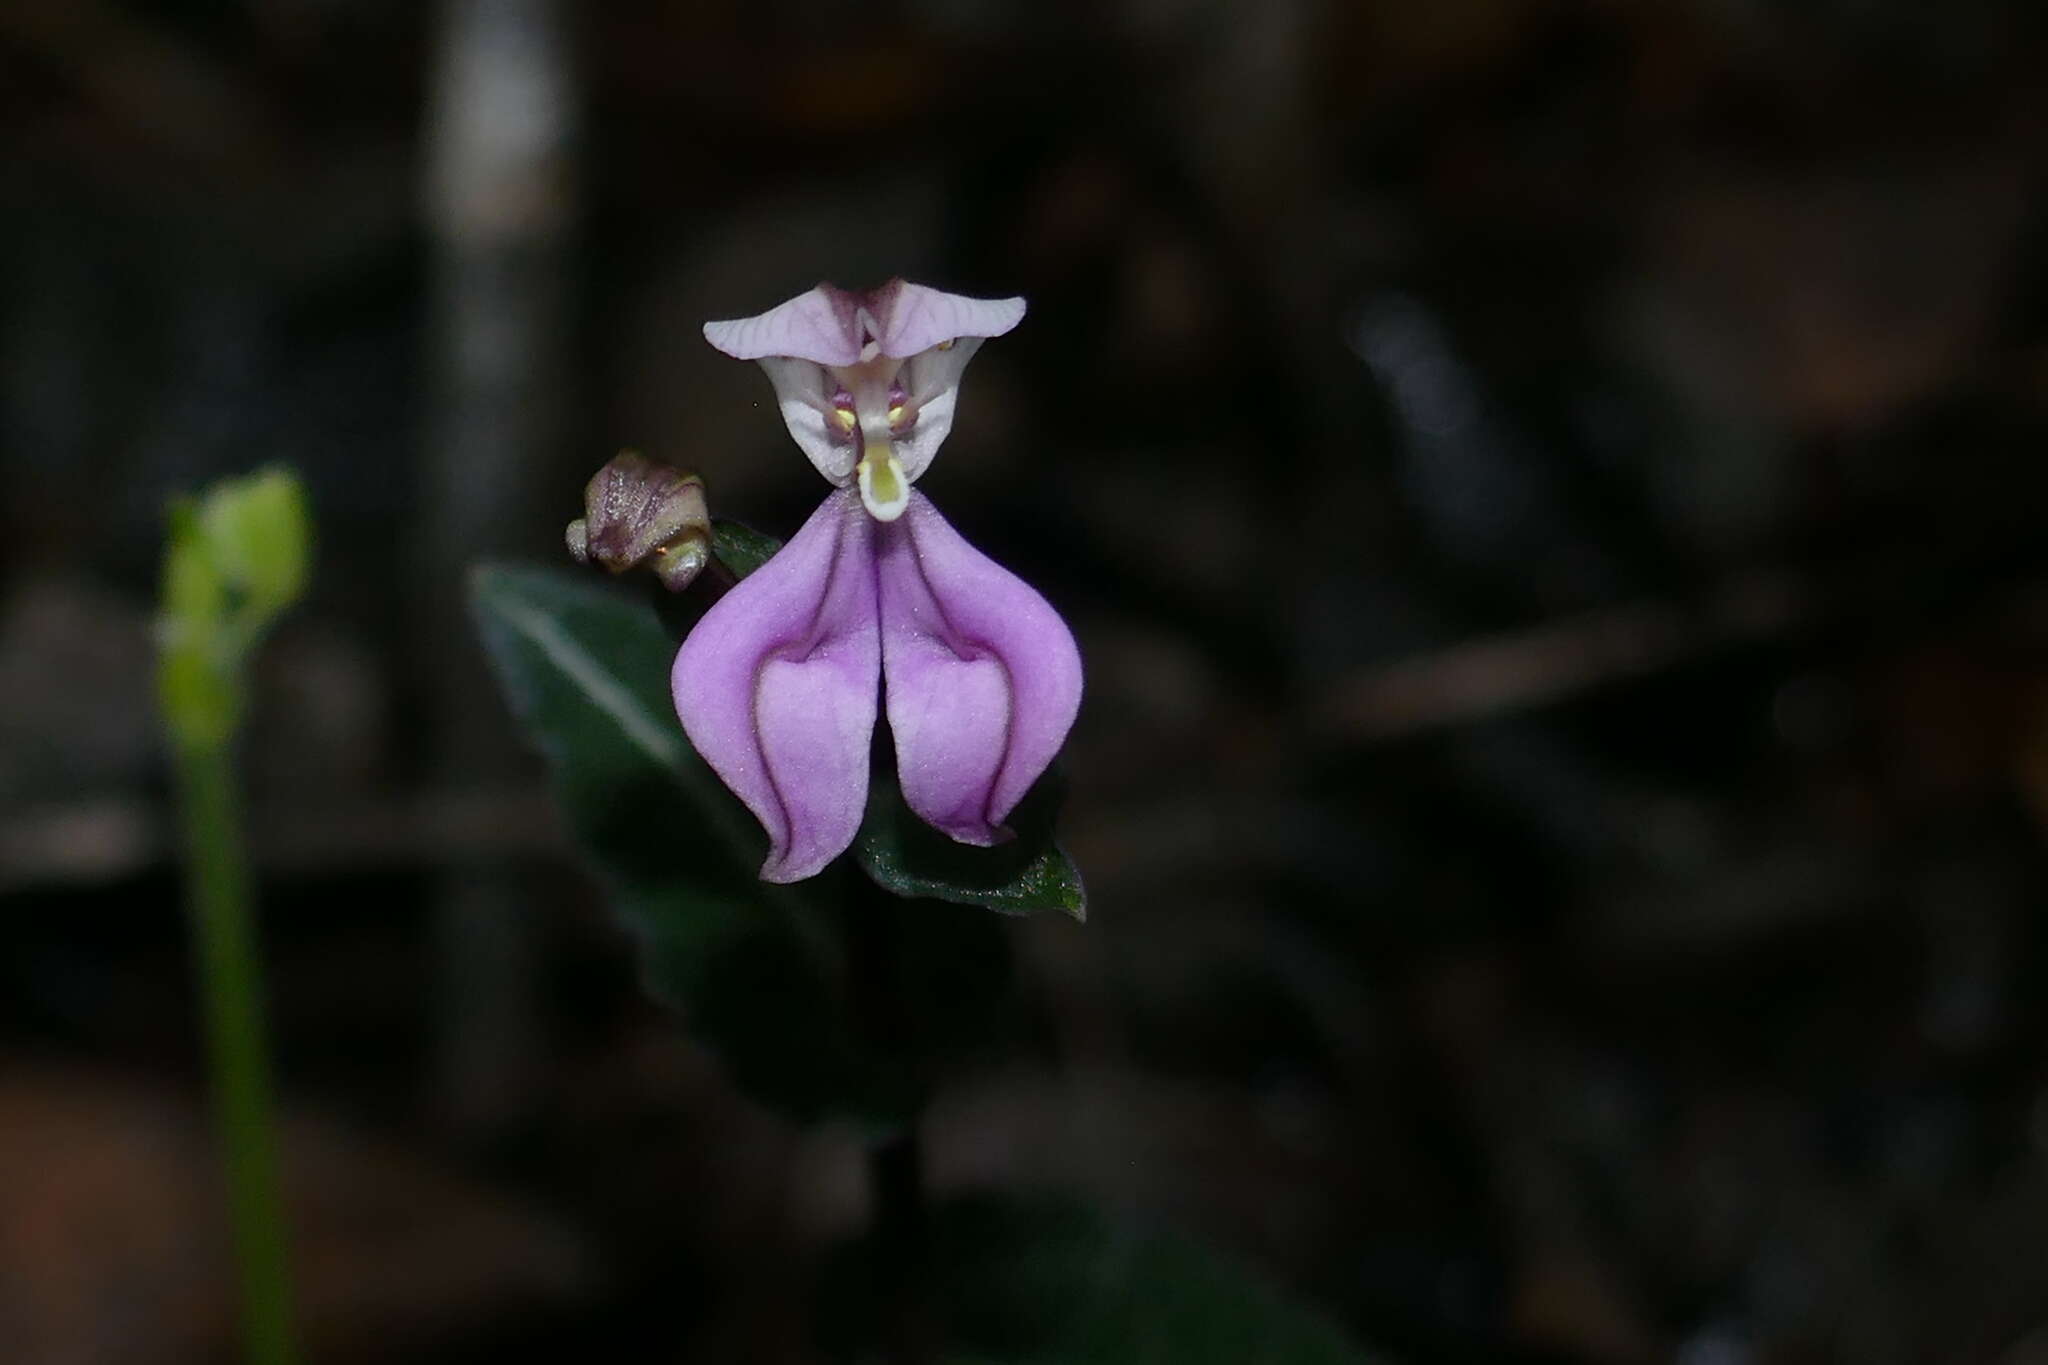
[823,1193,1378,1365]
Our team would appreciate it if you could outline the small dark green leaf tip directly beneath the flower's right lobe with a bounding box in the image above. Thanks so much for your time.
[854,774,1087,919]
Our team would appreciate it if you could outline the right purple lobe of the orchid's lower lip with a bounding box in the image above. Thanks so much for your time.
[879,491,1081,843]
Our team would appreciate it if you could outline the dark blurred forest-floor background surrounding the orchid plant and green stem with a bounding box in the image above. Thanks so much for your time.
[0,0,2048,1365]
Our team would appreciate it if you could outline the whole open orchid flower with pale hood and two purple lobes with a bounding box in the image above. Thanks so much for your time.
[672,280,1081,882]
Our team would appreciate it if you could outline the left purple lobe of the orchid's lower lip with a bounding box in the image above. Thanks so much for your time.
[670,489,881,882]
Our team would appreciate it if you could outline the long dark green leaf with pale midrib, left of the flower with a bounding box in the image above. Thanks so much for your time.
[471,567,872,1119]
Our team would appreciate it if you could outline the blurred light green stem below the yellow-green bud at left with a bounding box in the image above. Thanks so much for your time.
[176,745,297,1365]
